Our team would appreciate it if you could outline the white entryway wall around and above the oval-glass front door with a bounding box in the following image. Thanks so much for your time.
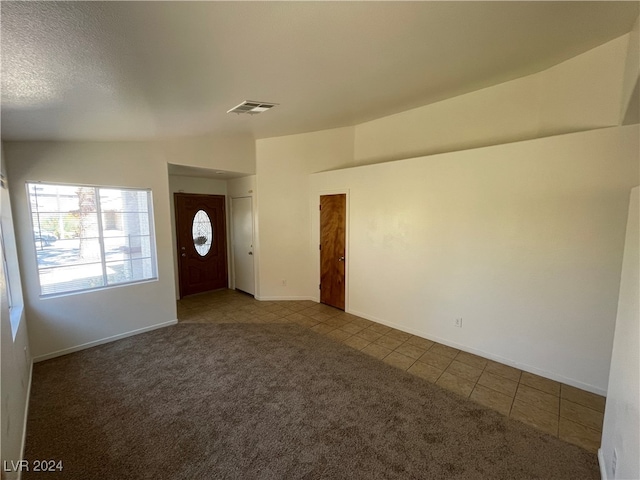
[169,175,230,298]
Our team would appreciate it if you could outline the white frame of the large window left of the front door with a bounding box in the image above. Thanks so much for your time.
[25,181,158,298]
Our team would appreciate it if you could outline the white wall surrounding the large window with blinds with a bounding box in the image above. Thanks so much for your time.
[5,142,176,360]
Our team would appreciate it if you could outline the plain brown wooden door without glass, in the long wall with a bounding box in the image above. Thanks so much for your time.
[320,194,347,310]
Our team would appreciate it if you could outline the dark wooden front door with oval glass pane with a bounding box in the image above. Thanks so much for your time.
[174,193,228,297]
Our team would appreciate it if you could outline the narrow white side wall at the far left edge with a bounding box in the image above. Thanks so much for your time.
[0,148,31,480]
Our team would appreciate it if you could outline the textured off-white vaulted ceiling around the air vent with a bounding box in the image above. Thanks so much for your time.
[0,1,638,140]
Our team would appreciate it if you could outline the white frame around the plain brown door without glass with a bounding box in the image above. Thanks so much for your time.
[310,188,351,313]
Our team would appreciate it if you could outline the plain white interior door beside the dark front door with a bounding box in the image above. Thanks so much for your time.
[231,197,255,295]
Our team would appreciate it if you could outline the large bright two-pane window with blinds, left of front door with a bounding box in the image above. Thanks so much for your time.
[27,183,157,296]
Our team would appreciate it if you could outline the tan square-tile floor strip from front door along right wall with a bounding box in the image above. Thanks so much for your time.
[178,290,605,453]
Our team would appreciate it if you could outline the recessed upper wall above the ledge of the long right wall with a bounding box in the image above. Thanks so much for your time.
[354,34,629,164]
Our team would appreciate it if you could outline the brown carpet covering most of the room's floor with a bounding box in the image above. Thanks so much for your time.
[23,324,599,480]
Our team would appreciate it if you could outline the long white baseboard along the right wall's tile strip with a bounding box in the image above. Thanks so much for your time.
[348,310,607,396]
